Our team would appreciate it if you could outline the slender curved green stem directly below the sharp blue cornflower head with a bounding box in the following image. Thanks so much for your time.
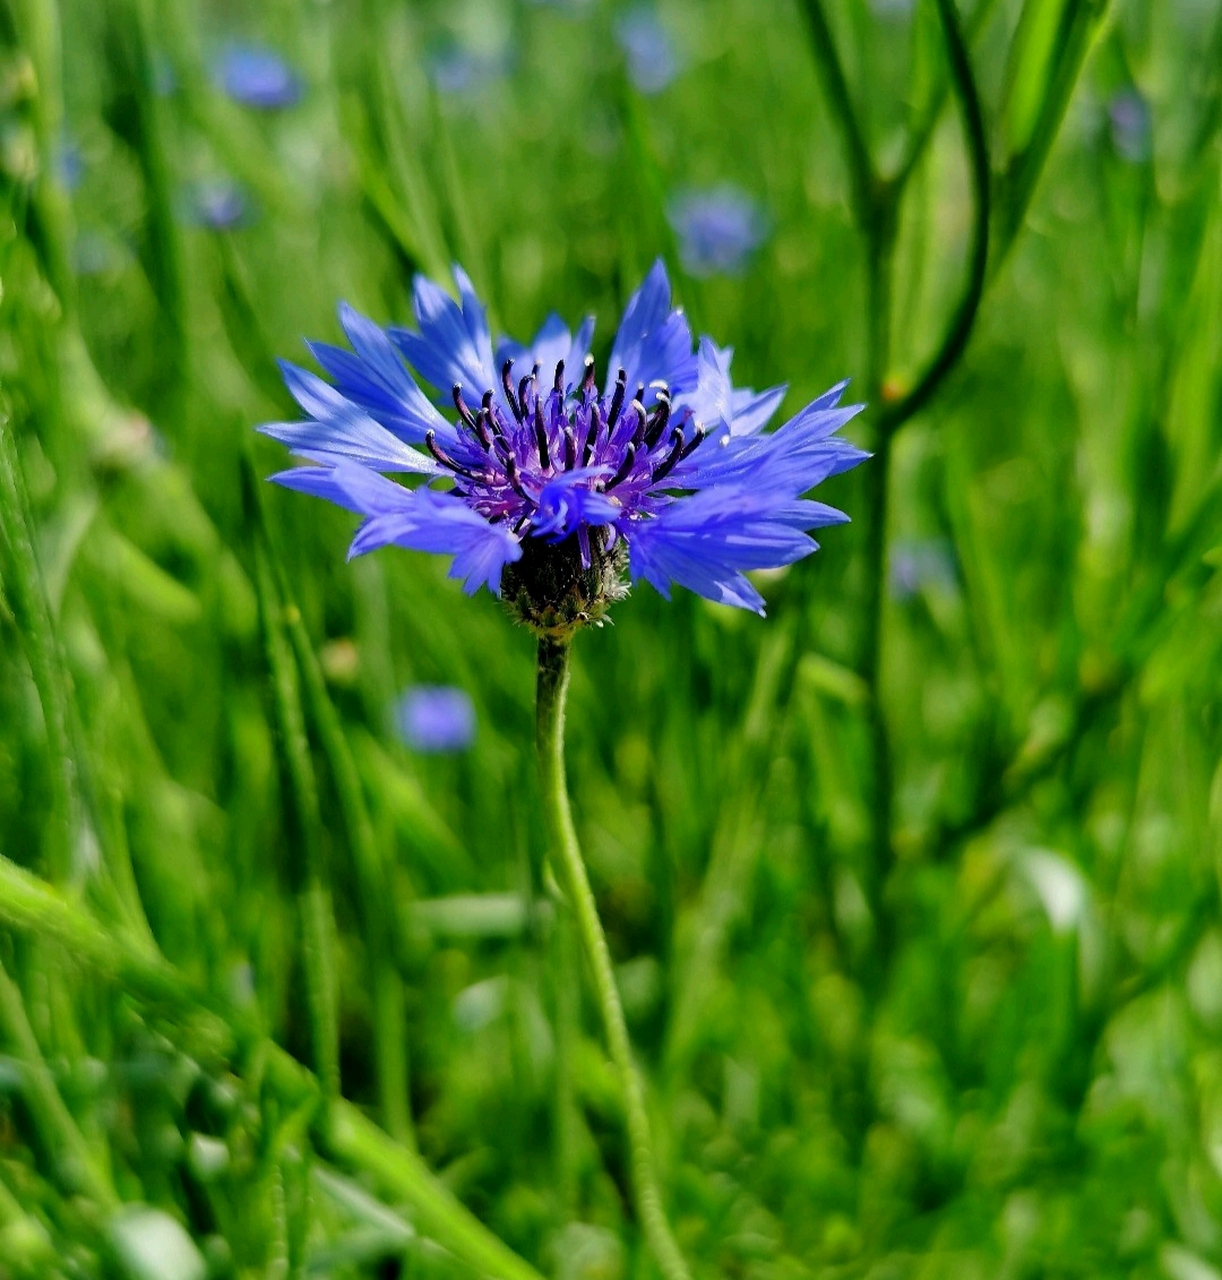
[535,636,690,1280]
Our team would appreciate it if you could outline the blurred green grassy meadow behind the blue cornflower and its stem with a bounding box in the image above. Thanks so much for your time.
[0,0,1222,1280]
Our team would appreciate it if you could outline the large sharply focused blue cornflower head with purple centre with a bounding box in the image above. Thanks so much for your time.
[260,261,868,636]
